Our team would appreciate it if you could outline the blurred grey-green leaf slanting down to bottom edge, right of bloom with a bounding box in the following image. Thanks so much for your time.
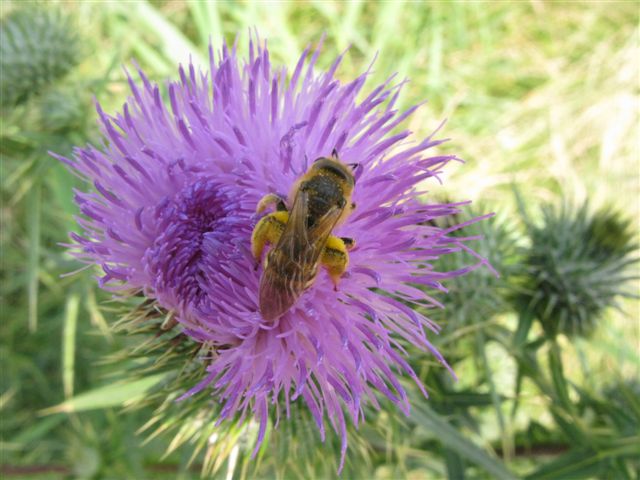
[411,402,516,480]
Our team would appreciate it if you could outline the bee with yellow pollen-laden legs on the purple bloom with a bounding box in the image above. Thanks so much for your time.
[251,150,357,320]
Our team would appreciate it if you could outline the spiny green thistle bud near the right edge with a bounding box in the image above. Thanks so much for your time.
[516,202,638,336]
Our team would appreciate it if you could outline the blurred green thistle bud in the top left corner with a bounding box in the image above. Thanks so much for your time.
[0,7,80,107]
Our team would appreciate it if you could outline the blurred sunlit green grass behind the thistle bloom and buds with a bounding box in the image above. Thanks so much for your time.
[0,1,640,479]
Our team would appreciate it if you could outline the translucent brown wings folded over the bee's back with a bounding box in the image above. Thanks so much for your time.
[260,190,343,320]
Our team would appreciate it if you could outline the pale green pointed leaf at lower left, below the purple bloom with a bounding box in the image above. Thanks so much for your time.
[42,373,165,415]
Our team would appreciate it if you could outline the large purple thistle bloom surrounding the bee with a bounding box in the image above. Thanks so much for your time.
[58,38,486,468]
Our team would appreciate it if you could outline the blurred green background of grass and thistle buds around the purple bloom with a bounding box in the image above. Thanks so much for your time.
[0,0,640,480]
